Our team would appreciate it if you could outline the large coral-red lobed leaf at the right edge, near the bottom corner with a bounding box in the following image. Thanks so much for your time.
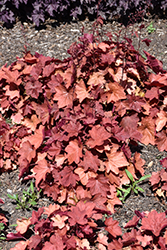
[141,210,167,237]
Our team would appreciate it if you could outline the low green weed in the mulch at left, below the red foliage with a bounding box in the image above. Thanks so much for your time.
[7,182,42,210]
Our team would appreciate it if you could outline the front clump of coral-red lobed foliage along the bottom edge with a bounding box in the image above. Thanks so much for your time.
[7,207,167,250]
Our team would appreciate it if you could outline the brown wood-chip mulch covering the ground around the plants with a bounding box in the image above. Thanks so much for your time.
[0,14,167,250]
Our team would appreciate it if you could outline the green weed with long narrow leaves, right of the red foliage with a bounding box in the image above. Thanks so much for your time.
[117,169,151,203]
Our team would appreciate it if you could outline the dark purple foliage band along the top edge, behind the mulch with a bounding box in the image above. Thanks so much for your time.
[0,0,167,26]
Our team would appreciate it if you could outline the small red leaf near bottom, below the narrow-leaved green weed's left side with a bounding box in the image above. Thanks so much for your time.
[104,217,122,238]
